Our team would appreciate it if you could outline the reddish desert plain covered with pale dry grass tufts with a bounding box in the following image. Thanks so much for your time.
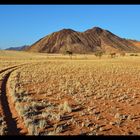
[0,50,140,135]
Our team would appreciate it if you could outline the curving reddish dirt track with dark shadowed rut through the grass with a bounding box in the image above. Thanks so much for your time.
[0,66,27,135]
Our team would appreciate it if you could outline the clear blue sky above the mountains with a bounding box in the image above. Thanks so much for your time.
[0,5,140,49]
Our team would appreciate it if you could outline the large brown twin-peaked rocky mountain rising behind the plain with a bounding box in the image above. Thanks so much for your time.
[26,27,140,53]
